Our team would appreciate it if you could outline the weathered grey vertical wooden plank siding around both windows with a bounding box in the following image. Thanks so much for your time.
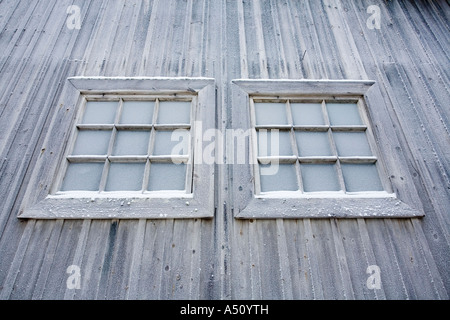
[0,0,450,299]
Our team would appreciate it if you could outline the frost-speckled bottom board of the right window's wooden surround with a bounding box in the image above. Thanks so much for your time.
[235,195,424,219]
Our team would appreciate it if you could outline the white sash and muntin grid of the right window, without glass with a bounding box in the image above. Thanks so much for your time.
[249,96,388,198]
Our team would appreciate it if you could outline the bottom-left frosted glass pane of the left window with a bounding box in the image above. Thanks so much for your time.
[61,162,103,191]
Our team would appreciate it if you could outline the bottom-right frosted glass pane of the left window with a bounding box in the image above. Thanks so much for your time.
[148,163,186,191]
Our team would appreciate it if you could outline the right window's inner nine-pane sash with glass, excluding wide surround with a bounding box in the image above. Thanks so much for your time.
[250,97,390,197]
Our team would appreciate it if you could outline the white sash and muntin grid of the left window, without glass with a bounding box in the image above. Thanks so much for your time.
[54,93,193,198]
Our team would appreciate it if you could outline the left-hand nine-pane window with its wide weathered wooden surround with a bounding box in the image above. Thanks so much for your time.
[19,77,215,219]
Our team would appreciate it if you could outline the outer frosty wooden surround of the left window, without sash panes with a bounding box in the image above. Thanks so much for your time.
[18,77,215,219]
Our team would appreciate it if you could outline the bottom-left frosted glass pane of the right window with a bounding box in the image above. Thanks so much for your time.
[259,164,298,192]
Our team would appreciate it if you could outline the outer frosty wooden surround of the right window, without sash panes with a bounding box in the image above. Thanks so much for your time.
[232,79,423,219]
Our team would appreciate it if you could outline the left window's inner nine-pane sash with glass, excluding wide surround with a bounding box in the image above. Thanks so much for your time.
[54,94,196,197]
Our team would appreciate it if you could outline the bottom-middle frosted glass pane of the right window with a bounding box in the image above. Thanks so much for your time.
[300,164,341,192]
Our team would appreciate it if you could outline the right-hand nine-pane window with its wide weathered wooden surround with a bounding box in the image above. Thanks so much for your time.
[233,80,422,218]
